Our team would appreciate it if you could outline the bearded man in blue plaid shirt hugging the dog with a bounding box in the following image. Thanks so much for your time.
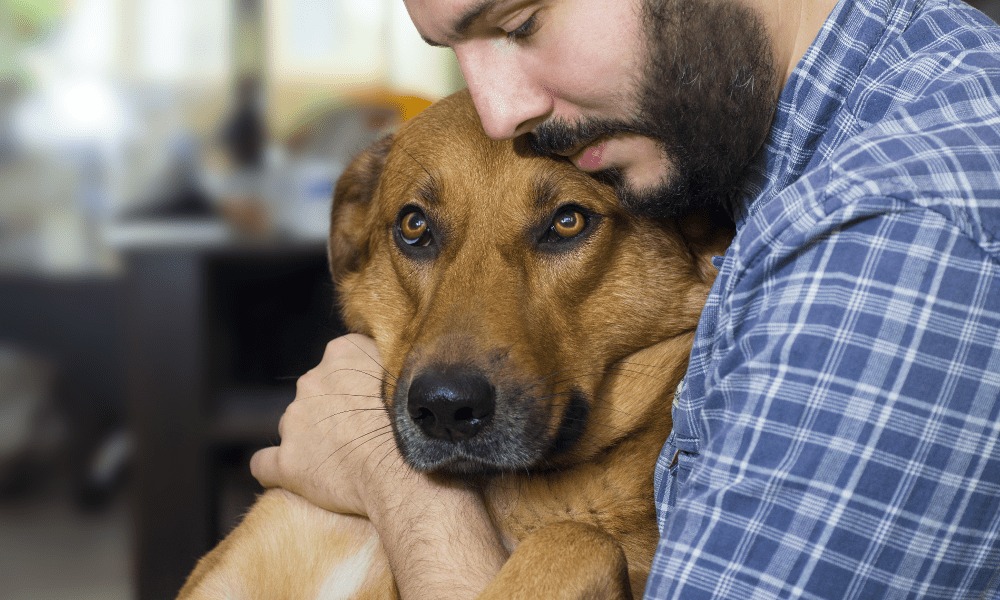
[253,0,1000,599]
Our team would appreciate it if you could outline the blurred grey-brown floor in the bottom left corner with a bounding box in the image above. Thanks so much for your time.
[0,494,133,600]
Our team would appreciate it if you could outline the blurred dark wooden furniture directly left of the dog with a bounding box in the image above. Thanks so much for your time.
[124,234,343,600]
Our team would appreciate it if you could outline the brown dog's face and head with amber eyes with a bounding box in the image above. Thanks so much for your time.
[330,92,724,473]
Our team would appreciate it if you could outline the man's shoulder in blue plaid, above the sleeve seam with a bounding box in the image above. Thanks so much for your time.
[746,0,1000,260]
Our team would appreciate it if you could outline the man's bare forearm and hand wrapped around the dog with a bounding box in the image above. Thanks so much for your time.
[251,335,507,599]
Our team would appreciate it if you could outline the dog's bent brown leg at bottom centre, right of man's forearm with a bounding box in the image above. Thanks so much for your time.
[479,521,632,600]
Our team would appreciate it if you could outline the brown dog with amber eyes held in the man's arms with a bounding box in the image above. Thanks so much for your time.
[180,92,729,599]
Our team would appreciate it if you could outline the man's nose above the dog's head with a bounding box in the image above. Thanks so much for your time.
[455,42,552,140]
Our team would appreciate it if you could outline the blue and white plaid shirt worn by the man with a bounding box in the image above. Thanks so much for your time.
[646,0,1000,600]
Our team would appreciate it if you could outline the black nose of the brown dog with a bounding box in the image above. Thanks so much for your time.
[406,367,495,442]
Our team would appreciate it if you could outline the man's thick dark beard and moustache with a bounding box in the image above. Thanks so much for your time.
[528,0,778,217]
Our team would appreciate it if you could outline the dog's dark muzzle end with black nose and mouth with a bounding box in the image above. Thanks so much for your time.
[392,366,589,475]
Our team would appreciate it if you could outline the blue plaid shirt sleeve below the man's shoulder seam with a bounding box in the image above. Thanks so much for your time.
[646,199,1000,600]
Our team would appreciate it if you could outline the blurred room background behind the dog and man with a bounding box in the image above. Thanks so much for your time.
[0,0,1000,600]
